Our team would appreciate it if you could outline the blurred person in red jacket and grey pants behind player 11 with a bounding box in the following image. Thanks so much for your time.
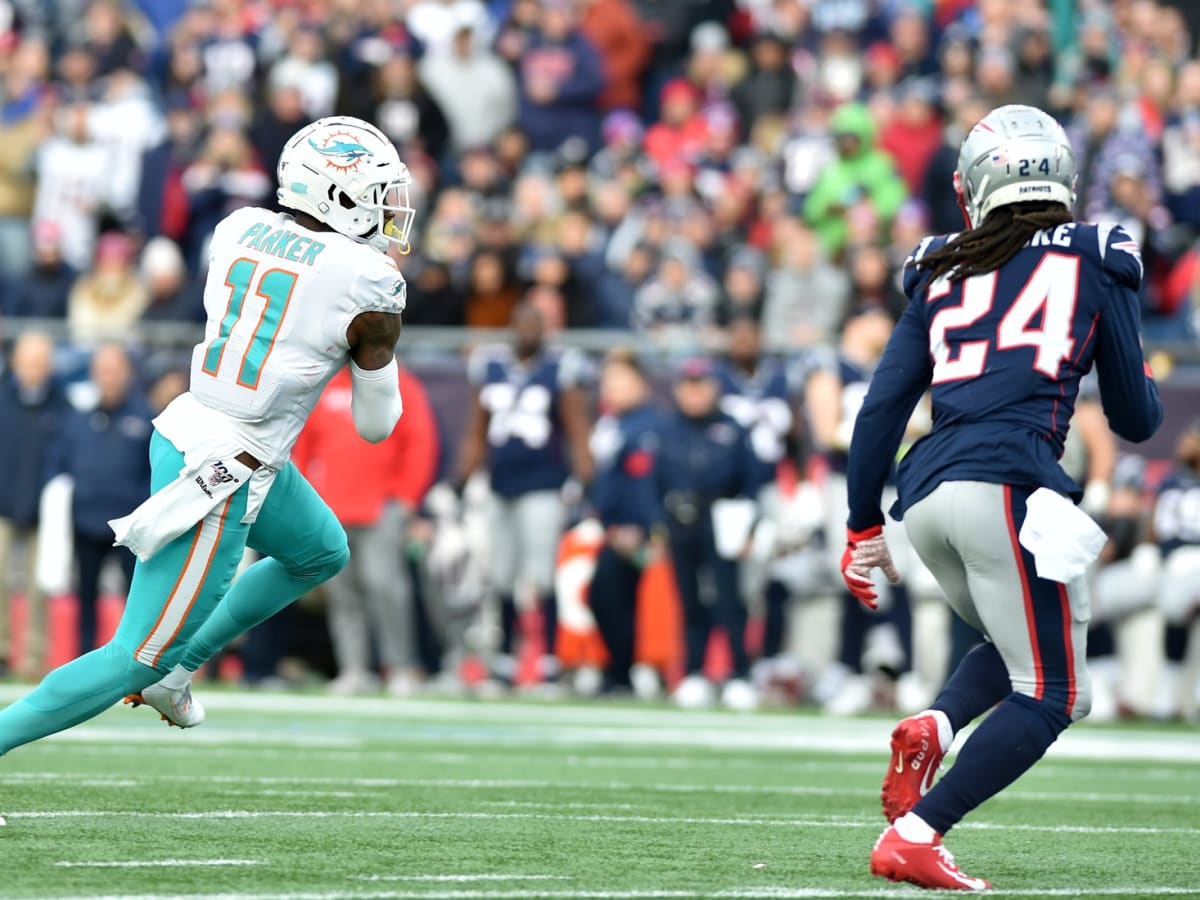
[293,368,438,696]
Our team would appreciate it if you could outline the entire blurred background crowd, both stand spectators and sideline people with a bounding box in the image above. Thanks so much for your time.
[0,0,1200,716]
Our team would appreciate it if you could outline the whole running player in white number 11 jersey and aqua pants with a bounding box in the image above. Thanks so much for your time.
[0,118,414,816]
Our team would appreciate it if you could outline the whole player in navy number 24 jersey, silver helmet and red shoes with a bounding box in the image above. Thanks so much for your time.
[842,106,1163,890]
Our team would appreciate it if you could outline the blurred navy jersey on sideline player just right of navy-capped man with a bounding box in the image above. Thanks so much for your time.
[718,358,797,488]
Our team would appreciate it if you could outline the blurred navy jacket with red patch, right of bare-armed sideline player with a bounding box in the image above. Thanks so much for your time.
[590,404,662,532]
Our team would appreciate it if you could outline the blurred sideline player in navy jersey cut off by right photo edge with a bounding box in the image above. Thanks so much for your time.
[1151,422,1200,719]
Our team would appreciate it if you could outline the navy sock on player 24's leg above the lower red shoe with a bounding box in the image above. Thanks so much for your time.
[912,694,1070,834]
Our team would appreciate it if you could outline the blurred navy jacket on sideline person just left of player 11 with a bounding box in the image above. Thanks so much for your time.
[47,392,152,538]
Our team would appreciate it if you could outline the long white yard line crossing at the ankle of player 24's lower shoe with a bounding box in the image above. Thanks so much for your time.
[5,809,1200,840]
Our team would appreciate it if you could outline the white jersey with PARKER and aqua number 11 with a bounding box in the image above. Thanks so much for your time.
[162,206,407,469]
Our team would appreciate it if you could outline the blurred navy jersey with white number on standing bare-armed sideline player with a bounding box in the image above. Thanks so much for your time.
[468,346,588,497]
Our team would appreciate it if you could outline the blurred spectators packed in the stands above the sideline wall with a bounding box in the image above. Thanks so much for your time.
[0,0,1200,347]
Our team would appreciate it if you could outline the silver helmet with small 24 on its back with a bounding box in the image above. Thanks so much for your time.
[954,104,1075,228]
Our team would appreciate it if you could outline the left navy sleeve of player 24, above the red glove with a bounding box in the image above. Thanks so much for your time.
[846,300,934,532]
